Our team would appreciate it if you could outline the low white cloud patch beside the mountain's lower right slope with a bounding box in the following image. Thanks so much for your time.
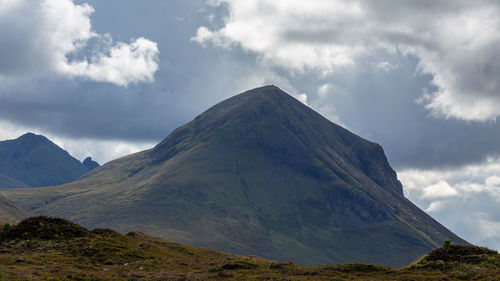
[398,158,500,250]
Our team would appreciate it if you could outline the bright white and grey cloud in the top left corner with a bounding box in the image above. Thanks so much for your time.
[0,0,159,86]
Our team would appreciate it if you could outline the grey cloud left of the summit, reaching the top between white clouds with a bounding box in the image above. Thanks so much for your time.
[0,1,278,141]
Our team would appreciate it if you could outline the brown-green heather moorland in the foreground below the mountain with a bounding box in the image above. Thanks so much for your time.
[0,217,500,280]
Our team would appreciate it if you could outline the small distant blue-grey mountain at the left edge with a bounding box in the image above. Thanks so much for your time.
[0,133,89,188]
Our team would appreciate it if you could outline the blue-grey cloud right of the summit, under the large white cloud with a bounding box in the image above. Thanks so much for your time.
[307,54,500,168]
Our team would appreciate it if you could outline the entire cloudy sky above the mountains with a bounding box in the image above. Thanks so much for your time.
[0,0,500,250]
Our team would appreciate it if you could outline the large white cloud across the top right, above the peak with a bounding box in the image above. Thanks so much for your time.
[192,0,500,121]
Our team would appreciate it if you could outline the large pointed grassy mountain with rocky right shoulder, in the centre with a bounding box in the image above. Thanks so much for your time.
[2,86,466,267]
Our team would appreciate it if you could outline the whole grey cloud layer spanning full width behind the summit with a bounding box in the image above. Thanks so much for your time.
[0,1,500,171]
